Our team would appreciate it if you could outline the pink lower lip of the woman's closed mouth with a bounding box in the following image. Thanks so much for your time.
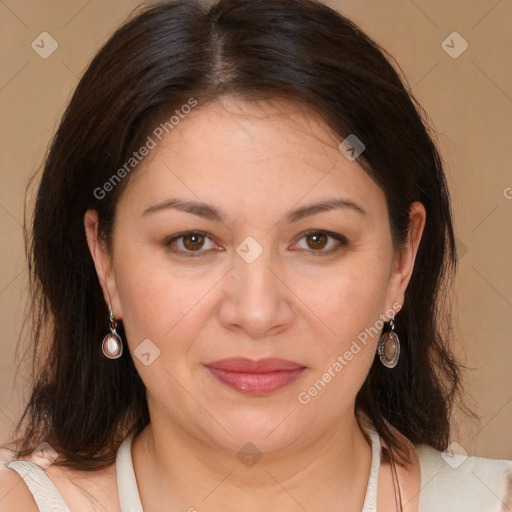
[207,366,305,395]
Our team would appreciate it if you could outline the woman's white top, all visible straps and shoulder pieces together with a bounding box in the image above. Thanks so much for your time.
[6,420,512,512]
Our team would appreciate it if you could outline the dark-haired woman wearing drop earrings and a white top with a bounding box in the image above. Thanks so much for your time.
[0,0,512,512]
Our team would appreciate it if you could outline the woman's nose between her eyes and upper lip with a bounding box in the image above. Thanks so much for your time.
[218,244,295,339]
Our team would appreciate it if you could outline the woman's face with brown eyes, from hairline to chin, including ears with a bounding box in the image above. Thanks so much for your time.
[85,98,423,452]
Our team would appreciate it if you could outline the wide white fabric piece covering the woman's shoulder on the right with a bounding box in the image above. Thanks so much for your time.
[415,445,512,512]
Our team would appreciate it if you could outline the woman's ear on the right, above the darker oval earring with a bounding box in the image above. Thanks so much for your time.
[387,201,427,312]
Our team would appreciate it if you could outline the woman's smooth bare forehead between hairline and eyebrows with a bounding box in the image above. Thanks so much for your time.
[118,97,384,221]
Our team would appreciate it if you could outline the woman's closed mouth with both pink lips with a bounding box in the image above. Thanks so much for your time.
[206,357,306,396]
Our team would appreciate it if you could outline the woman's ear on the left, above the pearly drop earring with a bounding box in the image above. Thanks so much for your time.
[84,209,122,320]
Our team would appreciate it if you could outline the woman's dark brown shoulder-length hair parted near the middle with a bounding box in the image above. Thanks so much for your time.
[11,0,468,469]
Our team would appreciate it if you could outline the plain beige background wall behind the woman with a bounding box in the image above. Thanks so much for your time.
[0,0,512,459]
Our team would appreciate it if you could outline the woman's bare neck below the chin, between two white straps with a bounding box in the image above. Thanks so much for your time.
[132,410,371,512]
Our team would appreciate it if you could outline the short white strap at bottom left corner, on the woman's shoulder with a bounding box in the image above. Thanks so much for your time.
[5,460,70,512]
